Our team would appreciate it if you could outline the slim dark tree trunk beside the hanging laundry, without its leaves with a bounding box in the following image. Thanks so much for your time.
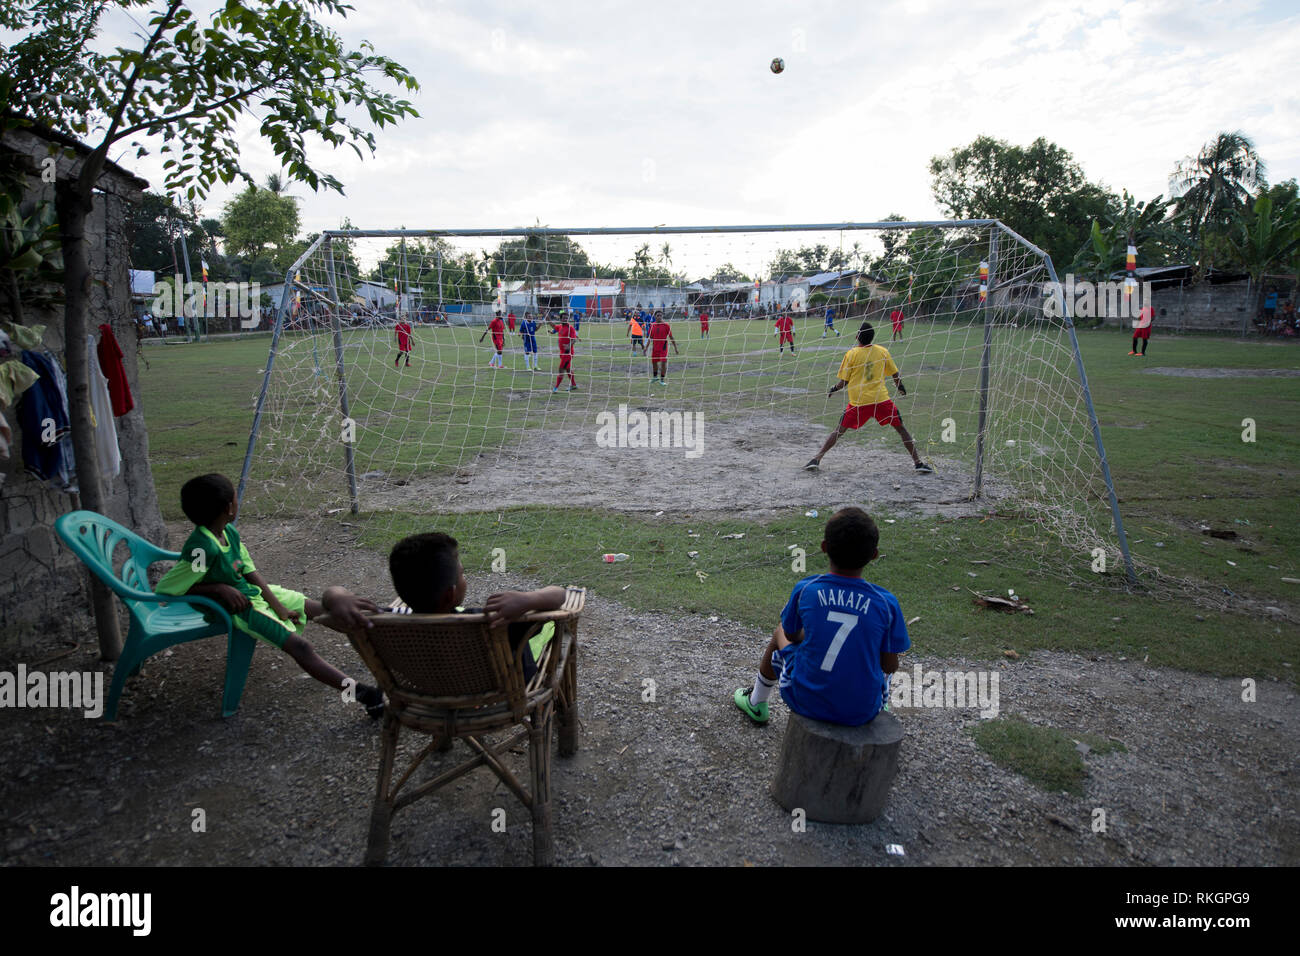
[55,177,122,661]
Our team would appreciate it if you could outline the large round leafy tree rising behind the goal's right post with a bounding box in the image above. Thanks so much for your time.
[930,137,1115,263]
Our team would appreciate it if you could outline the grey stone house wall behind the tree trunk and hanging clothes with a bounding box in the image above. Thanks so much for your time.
[0,128,165,658]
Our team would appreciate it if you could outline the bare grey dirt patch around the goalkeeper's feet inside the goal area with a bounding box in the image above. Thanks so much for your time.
[360,406,1006,516]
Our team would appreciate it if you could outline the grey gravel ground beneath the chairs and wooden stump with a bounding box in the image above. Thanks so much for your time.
[0,522,1300,865]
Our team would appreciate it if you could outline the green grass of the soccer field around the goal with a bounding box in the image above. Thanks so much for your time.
[140,320,1300,682]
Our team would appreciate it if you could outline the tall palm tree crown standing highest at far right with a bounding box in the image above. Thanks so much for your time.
[1169,133,1265,251]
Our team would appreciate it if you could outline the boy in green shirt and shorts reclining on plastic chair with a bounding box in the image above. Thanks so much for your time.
[155,475,384,717]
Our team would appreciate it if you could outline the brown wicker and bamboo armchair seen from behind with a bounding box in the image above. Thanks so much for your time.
[347,588,586,866]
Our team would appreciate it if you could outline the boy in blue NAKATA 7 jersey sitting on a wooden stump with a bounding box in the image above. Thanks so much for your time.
[732,507,911,727]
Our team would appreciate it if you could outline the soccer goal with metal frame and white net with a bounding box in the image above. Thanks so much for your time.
[239,220,1134,583]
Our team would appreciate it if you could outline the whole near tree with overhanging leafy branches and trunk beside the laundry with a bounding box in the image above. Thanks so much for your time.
[0,0,419,659]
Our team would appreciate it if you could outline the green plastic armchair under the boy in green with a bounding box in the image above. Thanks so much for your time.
[55,511,257,721]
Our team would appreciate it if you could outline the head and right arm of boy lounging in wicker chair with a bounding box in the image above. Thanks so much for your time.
[389,532,566,682]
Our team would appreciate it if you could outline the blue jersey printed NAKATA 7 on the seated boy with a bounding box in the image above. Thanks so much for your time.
[780,574,911,727]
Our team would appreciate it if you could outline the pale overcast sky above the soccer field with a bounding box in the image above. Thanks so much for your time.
[86,0,1300,269]
